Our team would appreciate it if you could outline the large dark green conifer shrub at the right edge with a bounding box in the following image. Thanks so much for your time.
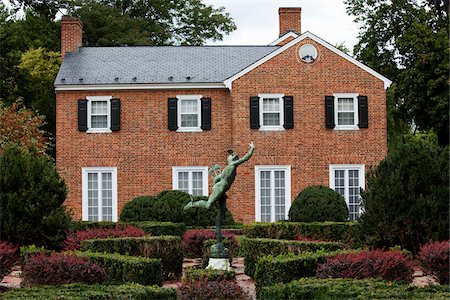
[360,142,450,254]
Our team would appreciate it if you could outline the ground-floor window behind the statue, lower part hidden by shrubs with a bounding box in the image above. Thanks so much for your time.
[172,167,208,196]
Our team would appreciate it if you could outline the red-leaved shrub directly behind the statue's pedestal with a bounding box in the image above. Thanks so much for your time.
[183,229,237,257]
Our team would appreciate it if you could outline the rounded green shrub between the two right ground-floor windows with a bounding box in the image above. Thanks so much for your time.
[289,185,348,222]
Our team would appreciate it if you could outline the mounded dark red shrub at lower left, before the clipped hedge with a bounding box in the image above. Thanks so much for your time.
[22,253,106,286]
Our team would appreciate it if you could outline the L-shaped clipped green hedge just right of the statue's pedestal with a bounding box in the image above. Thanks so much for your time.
[243,238,343,278]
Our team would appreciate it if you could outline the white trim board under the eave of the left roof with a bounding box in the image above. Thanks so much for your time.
[55,82,227,92]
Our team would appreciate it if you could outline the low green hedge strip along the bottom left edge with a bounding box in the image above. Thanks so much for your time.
[1,284,177,300]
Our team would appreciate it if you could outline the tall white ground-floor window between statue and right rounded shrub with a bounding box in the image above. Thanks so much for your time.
[255,166,291,222]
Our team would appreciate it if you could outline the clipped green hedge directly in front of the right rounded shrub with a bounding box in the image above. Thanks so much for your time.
[244,222,358,244]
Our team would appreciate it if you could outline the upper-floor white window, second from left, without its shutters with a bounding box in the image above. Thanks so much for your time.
[177,95,202,131]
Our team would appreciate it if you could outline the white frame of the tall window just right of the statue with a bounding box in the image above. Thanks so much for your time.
[255,165,291,222]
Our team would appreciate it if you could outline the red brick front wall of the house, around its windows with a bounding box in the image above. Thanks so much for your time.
[57,40,387,222]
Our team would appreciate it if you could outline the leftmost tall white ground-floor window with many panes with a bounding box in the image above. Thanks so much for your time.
[82,168,117,222]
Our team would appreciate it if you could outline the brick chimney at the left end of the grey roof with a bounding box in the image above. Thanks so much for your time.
[61,16,83,59]
